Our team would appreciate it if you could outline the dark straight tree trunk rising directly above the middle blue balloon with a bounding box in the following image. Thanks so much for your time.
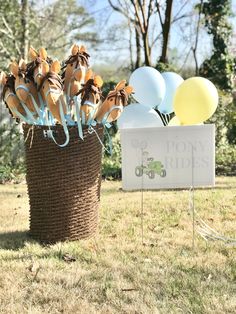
[160,0,173,63]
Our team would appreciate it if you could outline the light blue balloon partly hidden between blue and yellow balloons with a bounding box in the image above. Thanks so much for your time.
[158,72,184,113]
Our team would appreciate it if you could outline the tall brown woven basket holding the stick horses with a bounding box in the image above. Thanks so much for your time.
[23,125,103,243]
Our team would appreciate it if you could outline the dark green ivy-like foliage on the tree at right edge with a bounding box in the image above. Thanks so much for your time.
[200,0,236,90]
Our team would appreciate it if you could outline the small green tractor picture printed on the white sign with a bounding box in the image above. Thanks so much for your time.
[135,151,166,179]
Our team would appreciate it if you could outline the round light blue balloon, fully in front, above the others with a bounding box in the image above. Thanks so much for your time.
[129,67,165,108]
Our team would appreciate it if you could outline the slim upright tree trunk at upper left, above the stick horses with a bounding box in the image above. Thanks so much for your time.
[21,0,29,62]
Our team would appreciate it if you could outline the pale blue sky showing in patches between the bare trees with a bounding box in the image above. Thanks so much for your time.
[77,0,236,67]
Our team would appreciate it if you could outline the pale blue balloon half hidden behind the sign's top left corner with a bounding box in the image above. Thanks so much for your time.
[117,104,163,129]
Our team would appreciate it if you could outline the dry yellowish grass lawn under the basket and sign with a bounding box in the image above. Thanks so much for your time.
[0,177,236,314]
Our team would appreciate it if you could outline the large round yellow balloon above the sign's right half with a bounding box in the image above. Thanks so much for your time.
[174,77,218,125]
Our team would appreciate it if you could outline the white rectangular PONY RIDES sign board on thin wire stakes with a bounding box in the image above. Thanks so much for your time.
[120,124,215,190]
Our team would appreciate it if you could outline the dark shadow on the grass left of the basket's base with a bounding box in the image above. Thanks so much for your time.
[0,230,33,250]
